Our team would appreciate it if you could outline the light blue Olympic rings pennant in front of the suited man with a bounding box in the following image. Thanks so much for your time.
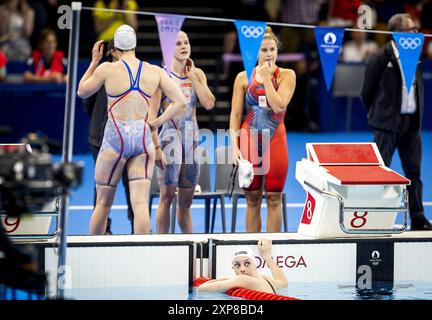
[392,32,424,92]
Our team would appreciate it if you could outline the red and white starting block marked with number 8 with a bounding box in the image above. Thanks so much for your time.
[296,143,411,238]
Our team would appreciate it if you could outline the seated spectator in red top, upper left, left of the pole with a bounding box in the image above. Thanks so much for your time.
[24,29,66,83]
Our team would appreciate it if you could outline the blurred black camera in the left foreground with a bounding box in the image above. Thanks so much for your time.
[0,135,83,294]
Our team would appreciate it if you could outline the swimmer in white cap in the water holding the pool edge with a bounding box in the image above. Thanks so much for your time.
[198,238,288,294]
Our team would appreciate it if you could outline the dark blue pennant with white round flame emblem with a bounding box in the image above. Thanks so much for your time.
[315,27,345,90]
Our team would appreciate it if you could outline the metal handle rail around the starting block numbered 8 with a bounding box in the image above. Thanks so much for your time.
[304,181,408,234]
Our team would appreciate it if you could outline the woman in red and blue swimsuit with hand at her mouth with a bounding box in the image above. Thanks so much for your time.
[230,27,296,232]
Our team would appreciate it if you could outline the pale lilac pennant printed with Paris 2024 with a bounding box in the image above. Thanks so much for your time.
[155,14,184,70]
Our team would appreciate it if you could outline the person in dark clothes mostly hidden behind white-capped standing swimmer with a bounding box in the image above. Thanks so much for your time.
[83,41,134,234]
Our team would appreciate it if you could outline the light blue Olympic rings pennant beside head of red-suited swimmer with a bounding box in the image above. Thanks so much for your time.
[234,20,266,82]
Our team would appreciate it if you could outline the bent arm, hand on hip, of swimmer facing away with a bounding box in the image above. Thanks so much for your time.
[150,67,186,130]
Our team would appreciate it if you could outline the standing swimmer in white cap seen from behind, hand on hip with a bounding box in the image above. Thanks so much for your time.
[78,25,186,234]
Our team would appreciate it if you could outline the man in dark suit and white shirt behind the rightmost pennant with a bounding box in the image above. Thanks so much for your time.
[362,14,432,230]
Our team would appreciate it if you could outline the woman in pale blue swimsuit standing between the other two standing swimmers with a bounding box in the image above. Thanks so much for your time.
[156,31,215,233]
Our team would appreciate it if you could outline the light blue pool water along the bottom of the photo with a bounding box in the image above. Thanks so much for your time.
[3,281,432,300]
